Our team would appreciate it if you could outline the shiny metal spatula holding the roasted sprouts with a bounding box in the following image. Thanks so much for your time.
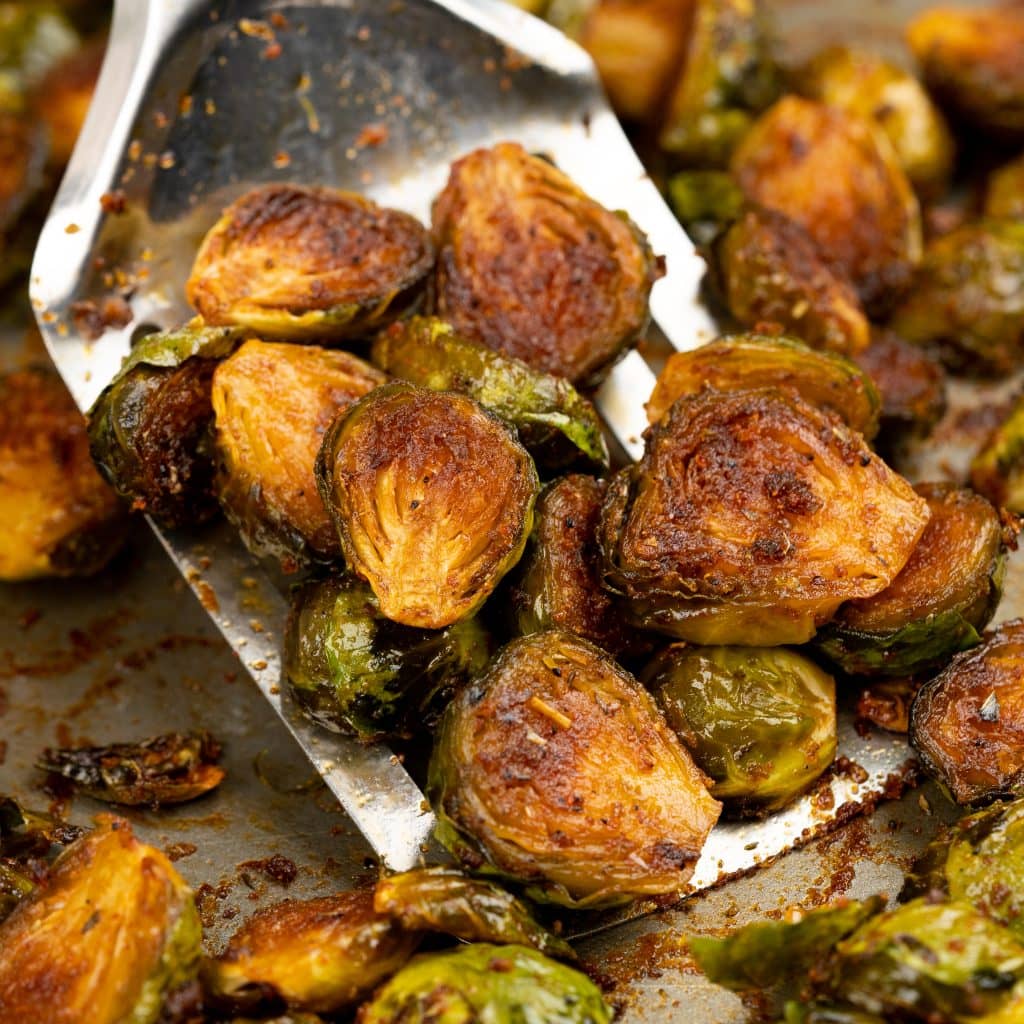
[31,0,908,890]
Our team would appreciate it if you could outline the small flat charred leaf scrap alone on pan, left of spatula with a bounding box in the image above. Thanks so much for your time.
[36,732,224,807]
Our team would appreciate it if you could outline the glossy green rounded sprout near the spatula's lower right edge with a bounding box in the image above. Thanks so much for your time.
[643,644,836,817]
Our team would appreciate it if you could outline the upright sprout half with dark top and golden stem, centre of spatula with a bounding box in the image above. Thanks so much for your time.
[316,383,540,629]
